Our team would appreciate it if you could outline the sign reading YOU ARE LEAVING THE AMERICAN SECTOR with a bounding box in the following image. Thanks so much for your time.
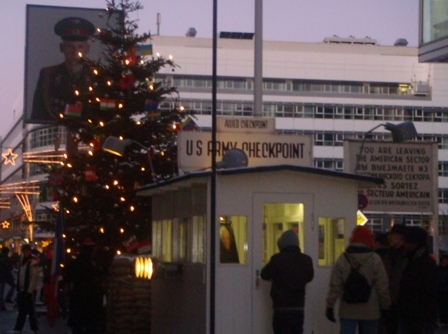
[344,141,438,212]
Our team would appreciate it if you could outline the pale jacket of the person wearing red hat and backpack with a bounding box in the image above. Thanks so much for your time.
[327,243,390,320]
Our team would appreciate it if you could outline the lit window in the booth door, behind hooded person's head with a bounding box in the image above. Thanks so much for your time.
[263,203,305,265]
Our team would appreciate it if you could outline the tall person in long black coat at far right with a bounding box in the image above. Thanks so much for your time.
[397,226,438,334]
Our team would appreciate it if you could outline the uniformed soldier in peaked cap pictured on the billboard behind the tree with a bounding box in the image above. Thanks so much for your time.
[30,17,95,123]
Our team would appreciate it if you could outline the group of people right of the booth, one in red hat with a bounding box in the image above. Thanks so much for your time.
[326,224,440,334]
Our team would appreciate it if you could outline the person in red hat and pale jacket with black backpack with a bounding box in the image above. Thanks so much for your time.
[325,226,390,334]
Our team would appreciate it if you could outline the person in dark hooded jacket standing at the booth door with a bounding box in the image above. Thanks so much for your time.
[261,230,314,334]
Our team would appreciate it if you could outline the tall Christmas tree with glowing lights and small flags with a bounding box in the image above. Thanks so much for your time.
[50,0,186,250]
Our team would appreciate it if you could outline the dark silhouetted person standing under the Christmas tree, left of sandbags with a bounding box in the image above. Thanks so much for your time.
[65,242,104,334]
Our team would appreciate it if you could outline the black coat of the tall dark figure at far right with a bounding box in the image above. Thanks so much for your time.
[397,247,439,322]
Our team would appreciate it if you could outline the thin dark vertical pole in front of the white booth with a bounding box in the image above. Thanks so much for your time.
[209,0,218,334]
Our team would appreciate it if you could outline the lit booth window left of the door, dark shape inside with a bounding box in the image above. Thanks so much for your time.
[219,216,247,264]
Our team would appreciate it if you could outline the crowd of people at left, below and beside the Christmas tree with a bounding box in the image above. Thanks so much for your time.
[0,241,112,334]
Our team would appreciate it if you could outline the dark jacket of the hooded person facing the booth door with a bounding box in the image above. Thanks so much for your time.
[261,246,314,309]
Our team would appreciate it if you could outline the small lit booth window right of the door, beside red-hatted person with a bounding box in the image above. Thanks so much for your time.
[319,217,346,266]
